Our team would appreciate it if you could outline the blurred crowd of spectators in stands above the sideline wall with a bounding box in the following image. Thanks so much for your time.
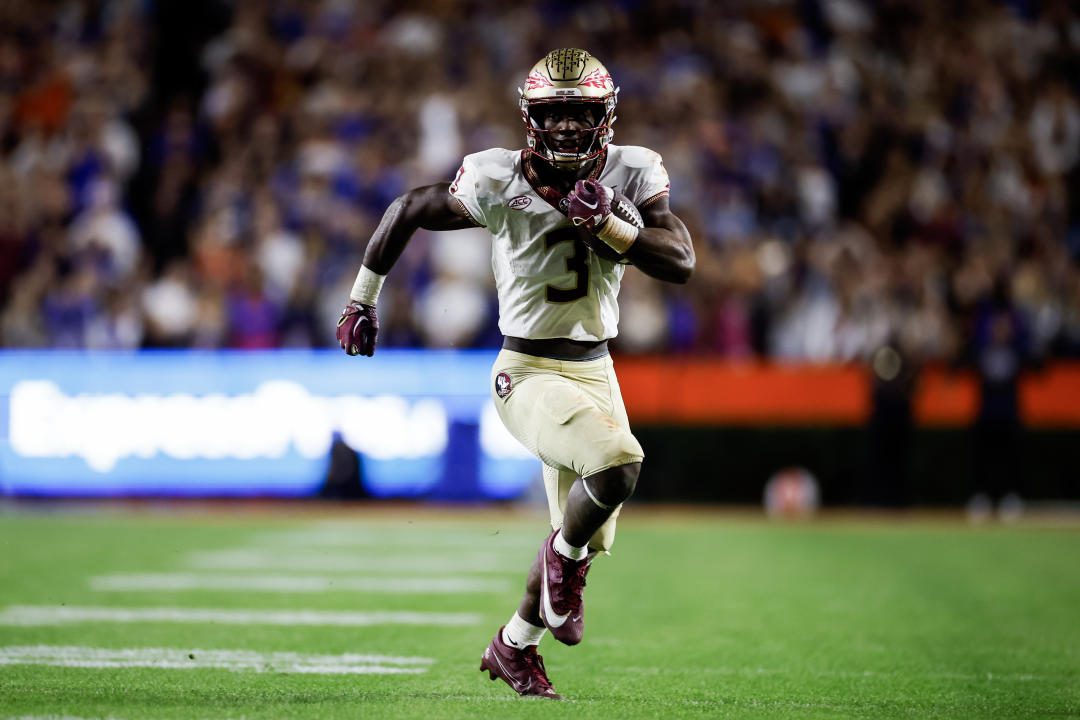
[0,0,1080,362]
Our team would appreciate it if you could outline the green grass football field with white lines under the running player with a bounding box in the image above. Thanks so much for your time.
[0,505,1080,720]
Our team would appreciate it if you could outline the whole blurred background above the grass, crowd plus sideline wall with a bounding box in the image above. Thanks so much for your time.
[0,0,1080,519]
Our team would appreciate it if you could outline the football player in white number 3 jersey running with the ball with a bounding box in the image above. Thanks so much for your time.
[337,49,694,698]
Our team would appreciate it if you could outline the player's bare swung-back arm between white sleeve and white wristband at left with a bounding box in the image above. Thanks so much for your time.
[364,182,476,275]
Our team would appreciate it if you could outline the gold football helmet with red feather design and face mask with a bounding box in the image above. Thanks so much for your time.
[517,47,619,168]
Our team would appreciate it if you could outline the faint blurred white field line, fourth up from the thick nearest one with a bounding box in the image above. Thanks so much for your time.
[188,549,523,574]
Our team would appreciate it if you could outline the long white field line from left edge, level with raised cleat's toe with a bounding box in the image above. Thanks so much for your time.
[0,606,483,627]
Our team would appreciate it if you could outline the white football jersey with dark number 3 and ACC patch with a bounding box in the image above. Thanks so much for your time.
[450,145,669,340]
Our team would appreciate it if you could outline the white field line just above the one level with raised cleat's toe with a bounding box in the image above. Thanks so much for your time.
[90,572,511,594]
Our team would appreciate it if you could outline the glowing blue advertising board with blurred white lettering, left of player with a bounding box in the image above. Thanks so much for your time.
[0,350,540,500]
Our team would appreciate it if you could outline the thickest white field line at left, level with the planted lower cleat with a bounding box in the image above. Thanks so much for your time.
[0,646,435,675]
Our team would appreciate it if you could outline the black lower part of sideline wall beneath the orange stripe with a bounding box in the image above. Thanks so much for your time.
[634,425,1080,507]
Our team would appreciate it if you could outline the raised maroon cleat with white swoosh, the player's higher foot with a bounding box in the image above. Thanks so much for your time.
[540,530,595,646]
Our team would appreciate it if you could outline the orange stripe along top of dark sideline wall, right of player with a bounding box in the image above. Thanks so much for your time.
[617,358,1080,427]
